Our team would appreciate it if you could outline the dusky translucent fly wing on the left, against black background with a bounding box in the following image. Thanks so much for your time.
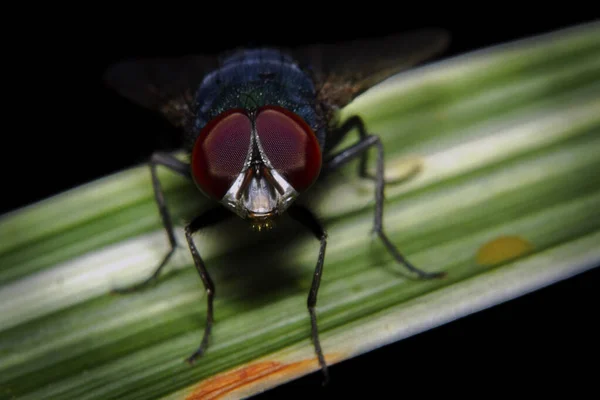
[104,55,218,127]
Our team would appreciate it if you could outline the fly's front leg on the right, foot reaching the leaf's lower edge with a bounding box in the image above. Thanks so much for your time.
[288,205,329,385]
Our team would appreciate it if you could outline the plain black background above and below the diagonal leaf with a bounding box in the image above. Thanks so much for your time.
[0,10,600,398]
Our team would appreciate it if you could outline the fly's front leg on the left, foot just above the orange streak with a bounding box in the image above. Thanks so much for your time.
[185,207,232,364]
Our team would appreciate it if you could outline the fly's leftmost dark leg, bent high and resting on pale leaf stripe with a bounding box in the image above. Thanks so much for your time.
[113,153,191,294]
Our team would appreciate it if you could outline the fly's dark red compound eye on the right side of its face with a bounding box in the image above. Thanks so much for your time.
[256,106,321,192]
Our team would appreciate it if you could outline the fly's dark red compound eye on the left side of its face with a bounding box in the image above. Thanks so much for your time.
[191,110,252,200]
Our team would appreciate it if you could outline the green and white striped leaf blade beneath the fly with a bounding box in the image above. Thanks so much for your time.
[0,24,600,399]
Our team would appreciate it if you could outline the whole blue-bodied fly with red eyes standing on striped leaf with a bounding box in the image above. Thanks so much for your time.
[105,30,448,381]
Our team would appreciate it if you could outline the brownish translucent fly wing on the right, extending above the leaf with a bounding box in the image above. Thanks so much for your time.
[292,29,450,108]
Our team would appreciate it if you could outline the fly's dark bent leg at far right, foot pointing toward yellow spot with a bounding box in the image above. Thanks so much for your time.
[324,116,446,279]
